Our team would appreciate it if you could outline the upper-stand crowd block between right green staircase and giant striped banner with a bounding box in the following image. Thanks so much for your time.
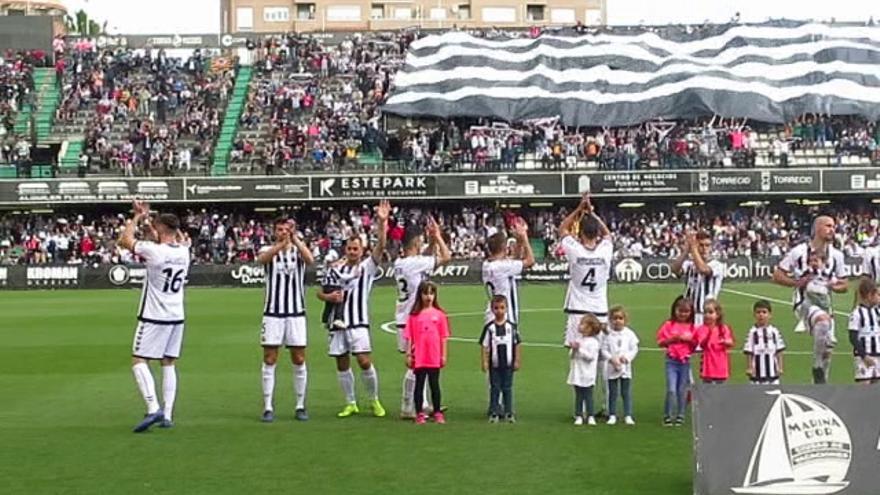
[231,31,415,173]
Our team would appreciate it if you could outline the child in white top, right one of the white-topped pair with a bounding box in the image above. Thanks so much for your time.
[602,306,639,425]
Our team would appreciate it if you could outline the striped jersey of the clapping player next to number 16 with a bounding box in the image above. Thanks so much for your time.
[263,247,306,318]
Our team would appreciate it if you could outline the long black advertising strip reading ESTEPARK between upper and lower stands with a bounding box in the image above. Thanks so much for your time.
[0,168,880,205]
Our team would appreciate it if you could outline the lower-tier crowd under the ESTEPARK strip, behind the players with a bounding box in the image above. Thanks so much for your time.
[0,205,880,264]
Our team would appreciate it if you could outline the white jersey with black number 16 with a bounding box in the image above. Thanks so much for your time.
[134,241,189,325]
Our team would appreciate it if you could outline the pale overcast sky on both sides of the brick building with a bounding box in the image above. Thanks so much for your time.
[62,0,880,34]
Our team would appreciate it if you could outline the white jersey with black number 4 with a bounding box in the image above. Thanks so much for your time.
[562,236,614,316]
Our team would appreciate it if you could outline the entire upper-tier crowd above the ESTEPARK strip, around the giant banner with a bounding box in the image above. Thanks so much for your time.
[0,26,880,175]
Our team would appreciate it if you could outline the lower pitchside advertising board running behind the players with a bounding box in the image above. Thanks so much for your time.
[0,257,862,289]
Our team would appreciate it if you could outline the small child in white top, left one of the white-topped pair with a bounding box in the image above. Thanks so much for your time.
[567,314,602,426]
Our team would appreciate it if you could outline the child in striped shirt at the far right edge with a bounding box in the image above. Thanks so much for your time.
[849,278,880,383]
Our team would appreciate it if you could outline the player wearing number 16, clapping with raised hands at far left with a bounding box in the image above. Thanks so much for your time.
[117,201,190,433]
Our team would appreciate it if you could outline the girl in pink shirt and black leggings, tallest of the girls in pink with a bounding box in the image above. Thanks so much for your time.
[403,282,449,425]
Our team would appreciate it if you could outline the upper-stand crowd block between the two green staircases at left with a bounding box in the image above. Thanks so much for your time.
[56,43,234,176]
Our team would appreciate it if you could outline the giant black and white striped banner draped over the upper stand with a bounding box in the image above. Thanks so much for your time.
[385,24,880,126]
